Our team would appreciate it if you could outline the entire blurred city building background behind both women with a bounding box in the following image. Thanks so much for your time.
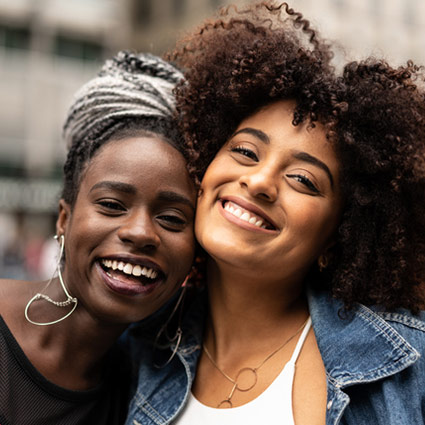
[0,0,425,279]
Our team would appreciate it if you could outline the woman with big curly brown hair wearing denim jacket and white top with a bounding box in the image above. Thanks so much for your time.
[124,2,425,425]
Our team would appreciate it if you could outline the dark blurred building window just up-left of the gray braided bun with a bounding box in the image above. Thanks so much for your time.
[54,34,103,62]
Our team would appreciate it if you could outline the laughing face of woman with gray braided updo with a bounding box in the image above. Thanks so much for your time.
[57,137,195,323]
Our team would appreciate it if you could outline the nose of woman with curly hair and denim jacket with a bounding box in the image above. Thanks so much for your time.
[239,165,278,202]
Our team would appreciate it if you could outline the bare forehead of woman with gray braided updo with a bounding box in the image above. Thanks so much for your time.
[81,136,191,190]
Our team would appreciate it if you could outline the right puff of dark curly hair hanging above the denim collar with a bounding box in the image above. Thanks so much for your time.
[329,59,425,311]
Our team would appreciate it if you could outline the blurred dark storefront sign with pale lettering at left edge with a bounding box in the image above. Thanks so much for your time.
[0,178,62,213]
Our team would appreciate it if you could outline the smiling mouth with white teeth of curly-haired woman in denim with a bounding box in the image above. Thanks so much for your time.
[221,199,277,231]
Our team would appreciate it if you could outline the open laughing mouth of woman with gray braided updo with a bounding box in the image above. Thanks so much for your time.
[97,258,165,295]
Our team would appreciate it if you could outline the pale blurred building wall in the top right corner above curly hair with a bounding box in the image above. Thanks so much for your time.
[290,0,425,64]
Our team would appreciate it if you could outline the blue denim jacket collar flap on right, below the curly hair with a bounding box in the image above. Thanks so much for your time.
[308,291,420,388]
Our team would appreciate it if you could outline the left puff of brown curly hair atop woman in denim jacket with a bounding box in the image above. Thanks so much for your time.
[167,2,332,184]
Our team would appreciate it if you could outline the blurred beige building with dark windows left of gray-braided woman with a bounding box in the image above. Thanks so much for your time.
[0,0,121,277]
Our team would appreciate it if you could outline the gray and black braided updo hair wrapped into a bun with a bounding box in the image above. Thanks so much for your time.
[62,51,185,205]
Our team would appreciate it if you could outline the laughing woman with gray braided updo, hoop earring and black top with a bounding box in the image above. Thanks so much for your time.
[0,52,196,425]
